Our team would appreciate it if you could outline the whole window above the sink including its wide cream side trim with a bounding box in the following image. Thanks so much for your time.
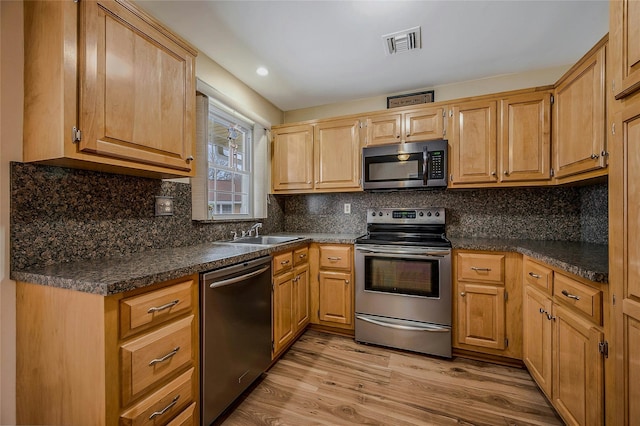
[191,80,271,221]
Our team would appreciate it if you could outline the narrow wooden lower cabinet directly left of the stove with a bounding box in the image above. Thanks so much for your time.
[310,244,355,331]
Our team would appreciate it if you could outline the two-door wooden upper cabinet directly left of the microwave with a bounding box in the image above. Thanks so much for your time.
[271,119,362,194]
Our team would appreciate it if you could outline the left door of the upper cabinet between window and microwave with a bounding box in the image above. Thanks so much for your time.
[271,125,313,192]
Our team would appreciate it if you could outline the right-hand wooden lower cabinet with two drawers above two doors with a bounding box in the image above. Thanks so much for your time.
[523,257,605,425]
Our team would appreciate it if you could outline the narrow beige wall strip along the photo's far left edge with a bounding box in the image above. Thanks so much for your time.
[0,0,24,425]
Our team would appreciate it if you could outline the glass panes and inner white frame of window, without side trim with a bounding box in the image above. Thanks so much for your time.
[207,100,253,218]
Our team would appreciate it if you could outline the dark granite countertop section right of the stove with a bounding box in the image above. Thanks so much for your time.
[450,238,609,283]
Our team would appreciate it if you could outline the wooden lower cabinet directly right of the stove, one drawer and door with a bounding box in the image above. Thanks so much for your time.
[453,250,522,359]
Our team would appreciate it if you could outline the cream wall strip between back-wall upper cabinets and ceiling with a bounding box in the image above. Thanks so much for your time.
[284,65,571,123]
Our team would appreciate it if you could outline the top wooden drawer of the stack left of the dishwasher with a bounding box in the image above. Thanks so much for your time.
[120,280,193,338]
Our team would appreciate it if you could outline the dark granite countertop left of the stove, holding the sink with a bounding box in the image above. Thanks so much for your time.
[11,233,360,296]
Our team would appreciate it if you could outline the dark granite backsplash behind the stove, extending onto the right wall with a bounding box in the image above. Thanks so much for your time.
[282,183,608,244]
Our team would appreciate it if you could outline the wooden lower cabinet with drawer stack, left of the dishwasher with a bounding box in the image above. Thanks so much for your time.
[16,275,200,425]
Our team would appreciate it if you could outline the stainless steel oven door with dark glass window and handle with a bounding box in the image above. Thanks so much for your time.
[355,244,452,326]
